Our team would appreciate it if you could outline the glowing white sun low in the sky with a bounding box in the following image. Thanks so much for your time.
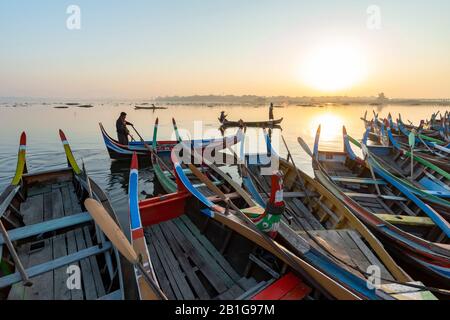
[301,44,366,92]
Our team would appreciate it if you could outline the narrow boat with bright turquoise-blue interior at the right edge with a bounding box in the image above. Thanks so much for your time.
[352,128,450,219]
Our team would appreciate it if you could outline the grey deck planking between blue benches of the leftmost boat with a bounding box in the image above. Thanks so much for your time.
[8,182,109,300]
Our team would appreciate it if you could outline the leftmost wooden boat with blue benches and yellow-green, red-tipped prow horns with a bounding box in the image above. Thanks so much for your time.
[0,131,132,300]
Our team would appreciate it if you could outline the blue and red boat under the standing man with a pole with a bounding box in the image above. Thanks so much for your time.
[99,123,239,160]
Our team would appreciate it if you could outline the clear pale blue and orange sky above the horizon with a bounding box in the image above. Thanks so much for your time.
[0,0,450,98]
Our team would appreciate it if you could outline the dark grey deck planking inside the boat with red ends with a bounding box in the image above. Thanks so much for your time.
[145,216,265,300]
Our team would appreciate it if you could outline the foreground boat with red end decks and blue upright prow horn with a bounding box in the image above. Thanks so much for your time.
[129,152,340,300]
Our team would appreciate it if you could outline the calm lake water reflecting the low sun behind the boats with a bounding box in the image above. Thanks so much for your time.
[0,102,445,228]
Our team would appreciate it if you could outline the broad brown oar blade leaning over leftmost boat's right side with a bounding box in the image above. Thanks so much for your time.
[84,198,167,300]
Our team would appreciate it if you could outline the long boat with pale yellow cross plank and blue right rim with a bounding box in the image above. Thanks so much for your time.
[306,127,450,288]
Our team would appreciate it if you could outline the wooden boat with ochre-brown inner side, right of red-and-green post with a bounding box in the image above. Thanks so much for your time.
[240,129,434,299]
